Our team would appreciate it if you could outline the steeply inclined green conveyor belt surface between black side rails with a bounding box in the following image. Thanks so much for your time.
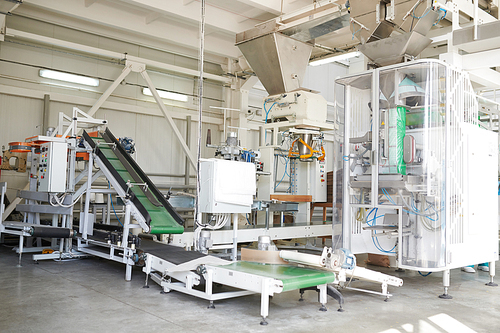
[92,137,184,234]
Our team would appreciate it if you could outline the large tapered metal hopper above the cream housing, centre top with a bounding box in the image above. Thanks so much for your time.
[237,33,313,95]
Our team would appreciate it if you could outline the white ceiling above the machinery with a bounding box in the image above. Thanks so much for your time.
[14,0,324,63]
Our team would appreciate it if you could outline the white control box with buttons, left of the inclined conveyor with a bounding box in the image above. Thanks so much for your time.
[38,142,68,193]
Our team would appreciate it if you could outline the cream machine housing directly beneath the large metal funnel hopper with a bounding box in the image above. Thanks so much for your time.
[262,90,327,123]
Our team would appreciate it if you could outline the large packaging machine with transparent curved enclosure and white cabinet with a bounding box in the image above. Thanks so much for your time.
[334,60,498,272]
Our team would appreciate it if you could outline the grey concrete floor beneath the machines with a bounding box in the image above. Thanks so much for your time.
[0,246,500,333]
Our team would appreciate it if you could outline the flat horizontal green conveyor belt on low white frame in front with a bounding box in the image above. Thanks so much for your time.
[221,261,335,291]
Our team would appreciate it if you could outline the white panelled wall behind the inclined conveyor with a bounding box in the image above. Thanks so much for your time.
[0,16,224,196]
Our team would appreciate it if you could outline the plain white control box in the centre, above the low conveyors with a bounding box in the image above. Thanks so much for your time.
[200,158,256,214]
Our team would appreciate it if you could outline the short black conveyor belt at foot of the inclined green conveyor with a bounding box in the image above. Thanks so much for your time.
[141,238,206,265]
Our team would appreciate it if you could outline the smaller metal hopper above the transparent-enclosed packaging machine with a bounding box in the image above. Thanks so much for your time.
[358,31,432,66]
